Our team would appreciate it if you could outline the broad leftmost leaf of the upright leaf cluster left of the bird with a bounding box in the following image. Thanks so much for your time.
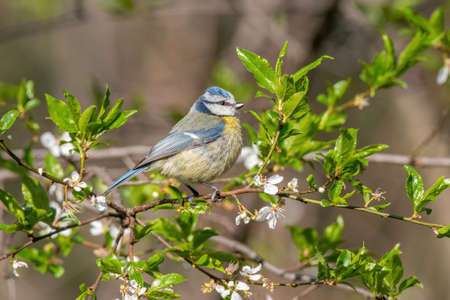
[45,94,78,132]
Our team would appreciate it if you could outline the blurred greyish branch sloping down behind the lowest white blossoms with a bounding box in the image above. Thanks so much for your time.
[211,236,373,298]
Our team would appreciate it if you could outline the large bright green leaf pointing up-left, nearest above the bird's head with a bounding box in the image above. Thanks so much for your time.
[236,48,276,94]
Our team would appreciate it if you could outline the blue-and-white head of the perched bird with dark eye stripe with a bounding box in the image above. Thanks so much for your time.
[191,86,244,116]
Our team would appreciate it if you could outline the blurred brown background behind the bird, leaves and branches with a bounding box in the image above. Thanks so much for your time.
[0,0,450,300]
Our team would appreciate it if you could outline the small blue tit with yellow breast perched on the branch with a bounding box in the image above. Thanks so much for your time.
[104,87,243,200]
